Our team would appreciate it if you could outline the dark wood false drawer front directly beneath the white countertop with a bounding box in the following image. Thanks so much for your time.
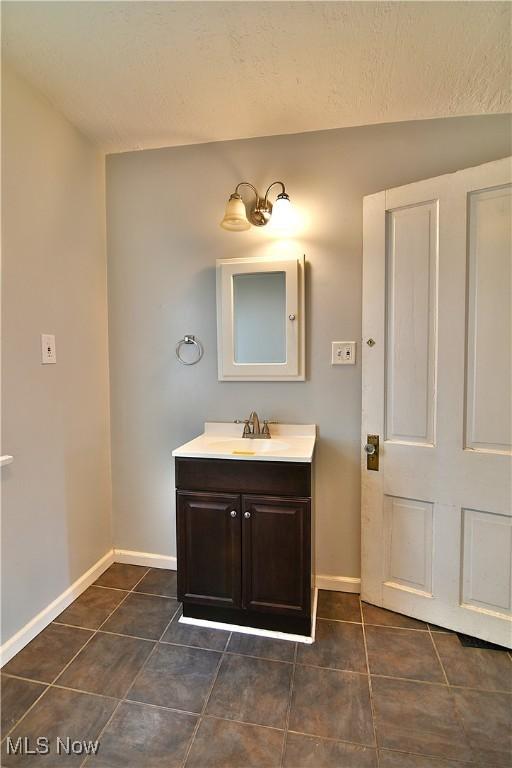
[176,458,311,496]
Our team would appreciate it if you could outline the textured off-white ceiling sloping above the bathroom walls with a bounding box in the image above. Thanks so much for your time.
[2,0,512,152]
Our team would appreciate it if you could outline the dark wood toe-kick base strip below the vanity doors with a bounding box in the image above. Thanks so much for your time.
[183,603,311,637]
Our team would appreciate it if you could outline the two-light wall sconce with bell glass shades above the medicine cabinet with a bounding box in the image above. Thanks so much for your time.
[220,181,294,232]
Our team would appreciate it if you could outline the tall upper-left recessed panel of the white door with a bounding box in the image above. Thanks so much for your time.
[385,201,438,445]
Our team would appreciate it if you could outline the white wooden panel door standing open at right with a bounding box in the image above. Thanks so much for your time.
[361,158,512,647]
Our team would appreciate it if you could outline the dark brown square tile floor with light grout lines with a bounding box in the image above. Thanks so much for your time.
[1,564,512,768]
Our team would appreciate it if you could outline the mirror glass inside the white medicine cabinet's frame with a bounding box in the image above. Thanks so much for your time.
[233,272,286,363]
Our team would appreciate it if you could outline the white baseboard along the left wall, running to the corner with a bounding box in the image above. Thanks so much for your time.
[0,549,115,667]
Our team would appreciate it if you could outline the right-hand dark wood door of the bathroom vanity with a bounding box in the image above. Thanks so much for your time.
[242,496,311,616]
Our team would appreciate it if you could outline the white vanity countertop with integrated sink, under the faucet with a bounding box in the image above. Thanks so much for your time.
[172,421,316,463]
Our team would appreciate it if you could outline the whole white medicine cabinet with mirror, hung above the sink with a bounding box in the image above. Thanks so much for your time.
[217,256,305,381]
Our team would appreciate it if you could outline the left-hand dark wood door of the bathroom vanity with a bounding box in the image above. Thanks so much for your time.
[176,491,242,608]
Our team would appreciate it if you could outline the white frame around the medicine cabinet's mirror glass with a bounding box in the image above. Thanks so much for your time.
[217,256,306,381]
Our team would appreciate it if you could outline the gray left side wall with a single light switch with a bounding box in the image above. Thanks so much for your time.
[1,63,112,640]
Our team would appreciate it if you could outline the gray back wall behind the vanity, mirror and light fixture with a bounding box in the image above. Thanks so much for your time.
[107,116,511,577]
